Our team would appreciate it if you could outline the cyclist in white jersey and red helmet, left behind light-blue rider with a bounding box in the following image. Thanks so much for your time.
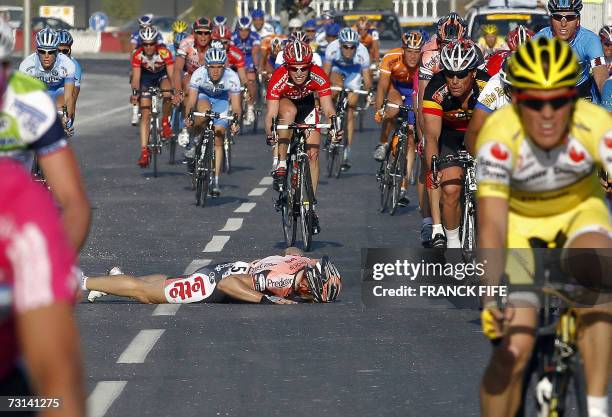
[172,17,213,105]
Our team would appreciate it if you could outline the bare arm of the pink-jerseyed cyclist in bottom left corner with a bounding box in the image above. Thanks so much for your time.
[17,301,85,417]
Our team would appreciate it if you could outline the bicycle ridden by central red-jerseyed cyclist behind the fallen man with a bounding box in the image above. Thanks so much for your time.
[272,118,334,251]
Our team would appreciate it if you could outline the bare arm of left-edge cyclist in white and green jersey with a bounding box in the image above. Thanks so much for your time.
[38,146,91,252]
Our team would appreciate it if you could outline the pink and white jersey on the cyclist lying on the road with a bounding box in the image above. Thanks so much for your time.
[248,255,317,297]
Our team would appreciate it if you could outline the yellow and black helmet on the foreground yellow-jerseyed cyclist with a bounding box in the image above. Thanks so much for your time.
[507,37,580,90]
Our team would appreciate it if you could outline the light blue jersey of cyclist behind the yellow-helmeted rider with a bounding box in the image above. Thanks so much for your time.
[534,26,606,90]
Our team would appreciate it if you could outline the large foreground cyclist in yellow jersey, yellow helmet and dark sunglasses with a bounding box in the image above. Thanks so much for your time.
[476,38,612,417]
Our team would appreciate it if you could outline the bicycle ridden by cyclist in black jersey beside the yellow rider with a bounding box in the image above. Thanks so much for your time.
[431,150,476,260]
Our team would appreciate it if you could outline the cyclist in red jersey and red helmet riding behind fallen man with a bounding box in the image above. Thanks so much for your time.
[265,41,342,234]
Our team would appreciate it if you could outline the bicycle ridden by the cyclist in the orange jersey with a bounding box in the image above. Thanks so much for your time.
[376,101,414,216]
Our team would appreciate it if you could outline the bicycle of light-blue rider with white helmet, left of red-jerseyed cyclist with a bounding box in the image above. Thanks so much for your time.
[190,110,236,207]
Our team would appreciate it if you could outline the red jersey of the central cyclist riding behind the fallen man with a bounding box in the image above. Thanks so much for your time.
[266,65,331,100]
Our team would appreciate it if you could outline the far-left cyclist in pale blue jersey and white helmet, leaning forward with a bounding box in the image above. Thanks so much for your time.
[19,28,76,134]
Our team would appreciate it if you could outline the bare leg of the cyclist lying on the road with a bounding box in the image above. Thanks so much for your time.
[86,274,167,304]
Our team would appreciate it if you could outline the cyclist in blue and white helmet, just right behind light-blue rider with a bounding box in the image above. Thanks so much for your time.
[232,16,261,126]
